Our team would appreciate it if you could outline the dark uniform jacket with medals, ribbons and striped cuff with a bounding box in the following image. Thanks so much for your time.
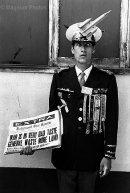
[49,67,118,171]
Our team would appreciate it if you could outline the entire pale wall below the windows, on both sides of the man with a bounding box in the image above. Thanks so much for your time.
[0,72,130,172]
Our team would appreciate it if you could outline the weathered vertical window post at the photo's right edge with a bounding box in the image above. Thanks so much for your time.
[120,0,130,68]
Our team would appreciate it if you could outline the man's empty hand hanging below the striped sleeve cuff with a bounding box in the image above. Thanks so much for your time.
[99,157,111,178]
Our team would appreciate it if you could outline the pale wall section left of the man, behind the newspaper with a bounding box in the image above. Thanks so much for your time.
[0,72,52,168]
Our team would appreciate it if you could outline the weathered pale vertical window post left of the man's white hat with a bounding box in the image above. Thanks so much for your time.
[49,0,59,66]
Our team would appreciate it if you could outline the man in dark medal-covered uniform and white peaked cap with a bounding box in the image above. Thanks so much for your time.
[49,12,118,193]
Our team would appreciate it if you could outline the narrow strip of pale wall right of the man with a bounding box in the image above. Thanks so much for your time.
[113,75,130,172]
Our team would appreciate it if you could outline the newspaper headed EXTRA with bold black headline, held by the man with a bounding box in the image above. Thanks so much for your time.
[4,110,63,154]
